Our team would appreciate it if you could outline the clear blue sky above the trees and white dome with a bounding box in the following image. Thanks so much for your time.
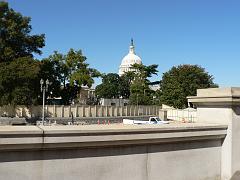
[7,0,240,87]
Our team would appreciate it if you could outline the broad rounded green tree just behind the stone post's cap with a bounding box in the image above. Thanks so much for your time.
[158,64,218,108]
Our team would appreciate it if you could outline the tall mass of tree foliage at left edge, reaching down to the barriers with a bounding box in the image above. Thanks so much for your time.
[0,2,44,105]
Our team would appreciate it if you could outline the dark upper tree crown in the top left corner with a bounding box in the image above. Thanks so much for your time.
[0,2,44,62]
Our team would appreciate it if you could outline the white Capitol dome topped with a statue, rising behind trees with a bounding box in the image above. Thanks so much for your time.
[119,40,142,76]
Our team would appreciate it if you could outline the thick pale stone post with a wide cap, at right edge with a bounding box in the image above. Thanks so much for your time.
[188,88,240,180]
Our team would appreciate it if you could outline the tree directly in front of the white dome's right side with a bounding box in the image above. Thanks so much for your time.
[129,64,158,105]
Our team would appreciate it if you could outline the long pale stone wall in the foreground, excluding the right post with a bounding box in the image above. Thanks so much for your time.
[0,124,227,180]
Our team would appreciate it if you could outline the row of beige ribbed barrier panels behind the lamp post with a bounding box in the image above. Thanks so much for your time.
[0,105,163,118]
